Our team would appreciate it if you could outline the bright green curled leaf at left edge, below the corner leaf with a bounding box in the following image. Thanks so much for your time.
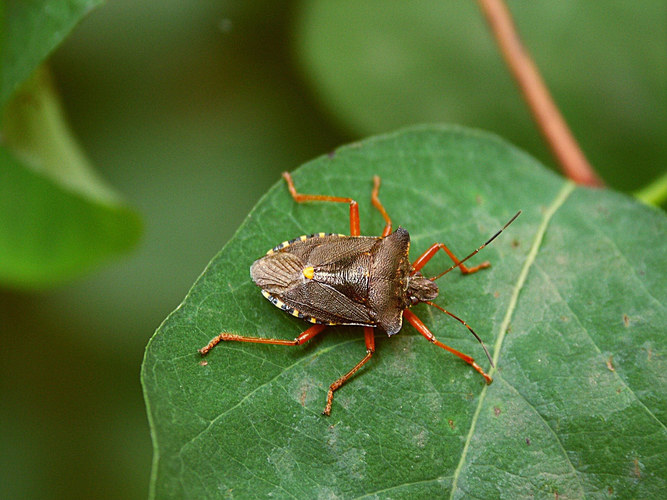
[0,68,141,289]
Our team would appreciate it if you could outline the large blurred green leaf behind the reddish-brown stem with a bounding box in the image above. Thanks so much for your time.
[294,0,667,191]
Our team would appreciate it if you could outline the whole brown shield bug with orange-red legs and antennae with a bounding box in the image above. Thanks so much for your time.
[199,172,521,415]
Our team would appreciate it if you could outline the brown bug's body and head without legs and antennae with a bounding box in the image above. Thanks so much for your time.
[250,227,438,335]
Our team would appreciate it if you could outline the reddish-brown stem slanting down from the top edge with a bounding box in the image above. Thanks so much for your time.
[479,0,603,186]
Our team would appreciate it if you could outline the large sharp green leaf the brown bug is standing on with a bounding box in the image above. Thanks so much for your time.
[142,126,667,498]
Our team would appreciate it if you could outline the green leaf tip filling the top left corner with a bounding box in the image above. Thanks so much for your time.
[0,0,102,108]
